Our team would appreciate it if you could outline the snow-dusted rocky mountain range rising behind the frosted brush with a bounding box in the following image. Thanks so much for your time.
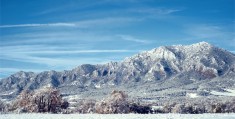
[0,42,235,99]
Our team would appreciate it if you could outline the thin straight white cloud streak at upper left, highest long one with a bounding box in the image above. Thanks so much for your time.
[0,23,76,28]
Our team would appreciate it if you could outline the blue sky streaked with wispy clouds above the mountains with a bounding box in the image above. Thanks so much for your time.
[0,0,235,78]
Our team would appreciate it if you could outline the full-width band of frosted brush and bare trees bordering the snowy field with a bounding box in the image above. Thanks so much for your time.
[0,88,235,114]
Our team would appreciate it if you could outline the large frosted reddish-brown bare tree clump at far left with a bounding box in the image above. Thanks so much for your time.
[9,88,69,113]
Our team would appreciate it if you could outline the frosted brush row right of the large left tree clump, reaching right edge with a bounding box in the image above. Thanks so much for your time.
[67,91,235,114]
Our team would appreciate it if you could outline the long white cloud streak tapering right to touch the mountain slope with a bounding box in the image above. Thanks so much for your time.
[0,45,138,57]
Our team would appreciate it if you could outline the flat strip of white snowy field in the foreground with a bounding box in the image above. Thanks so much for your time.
[0,113,235,119]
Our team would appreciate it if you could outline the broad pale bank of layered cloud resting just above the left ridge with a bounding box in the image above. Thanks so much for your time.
[0,41,138,77]
